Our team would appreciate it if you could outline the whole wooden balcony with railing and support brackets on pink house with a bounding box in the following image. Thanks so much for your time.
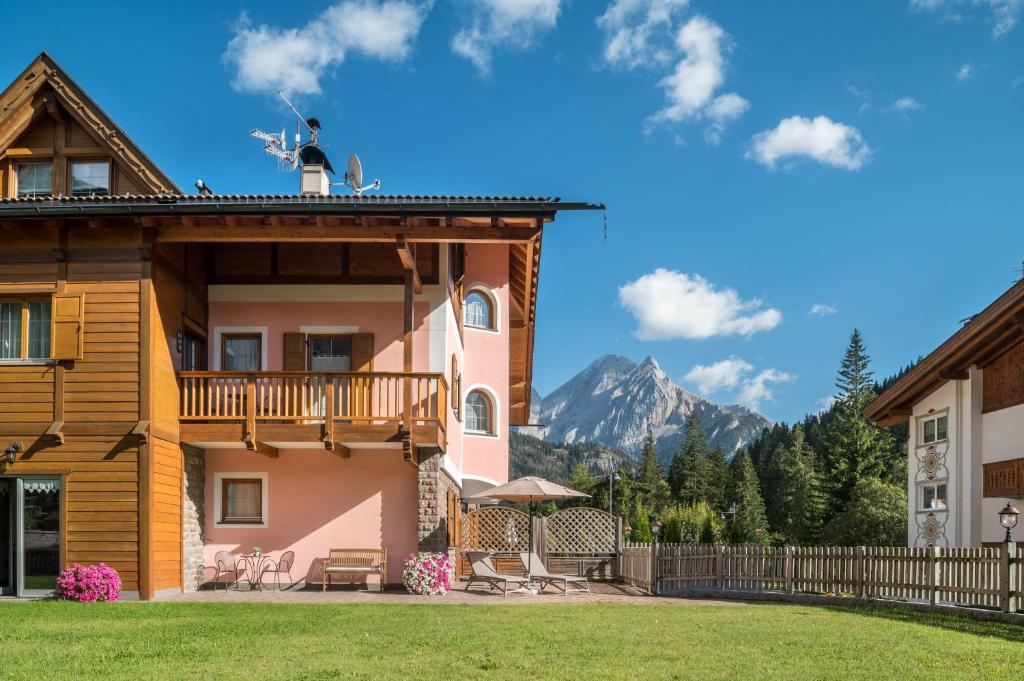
[178,372,447,461]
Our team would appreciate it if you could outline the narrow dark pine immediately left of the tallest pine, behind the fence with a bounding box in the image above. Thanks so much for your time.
[769,424,825,546]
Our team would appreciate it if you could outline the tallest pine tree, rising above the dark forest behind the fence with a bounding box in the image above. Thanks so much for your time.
[824,329,899,514]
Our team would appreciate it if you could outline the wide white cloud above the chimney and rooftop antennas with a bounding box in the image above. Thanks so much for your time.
[224,0,430,94]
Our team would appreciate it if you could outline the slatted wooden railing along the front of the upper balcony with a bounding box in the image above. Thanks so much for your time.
[178,372,447,428]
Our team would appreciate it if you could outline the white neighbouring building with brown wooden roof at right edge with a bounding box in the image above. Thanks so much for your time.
[866,282,1024,547]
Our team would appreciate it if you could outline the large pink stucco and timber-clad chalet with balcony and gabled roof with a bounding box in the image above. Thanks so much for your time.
[0,53,597,599]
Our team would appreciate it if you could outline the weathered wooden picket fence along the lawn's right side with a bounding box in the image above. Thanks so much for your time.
[618,544,1024,612]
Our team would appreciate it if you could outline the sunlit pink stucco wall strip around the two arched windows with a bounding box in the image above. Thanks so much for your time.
[463,244,509,482]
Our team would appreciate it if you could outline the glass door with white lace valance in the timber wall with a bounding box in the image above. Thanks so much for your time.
[13,477,61,596]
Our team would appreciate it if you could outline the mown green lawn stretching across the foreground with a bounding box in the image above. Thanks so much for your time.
[0,602,1024,681]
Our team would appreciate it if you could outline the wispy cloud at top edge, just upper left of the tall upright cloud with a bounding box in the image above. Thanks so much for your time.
[597,0,689,69]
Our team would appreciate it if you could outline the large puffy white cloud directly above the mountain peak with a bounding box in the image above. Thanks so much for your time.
[618,267,782,340]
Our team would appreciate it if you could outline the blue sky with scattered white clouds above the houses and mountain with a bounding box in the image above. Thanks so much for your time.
[8,0,1024,420]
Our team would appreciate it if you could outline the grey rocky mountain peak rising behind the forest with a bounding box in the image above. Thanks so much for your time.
[520,354,772,463]
